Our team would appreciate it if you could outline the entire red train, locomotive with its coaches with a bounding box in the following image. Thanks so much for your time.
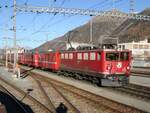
[18,46,131,86]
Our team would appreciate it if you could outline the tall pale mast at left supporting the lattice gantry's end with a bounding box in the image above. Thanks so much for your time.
[13,0,17,73]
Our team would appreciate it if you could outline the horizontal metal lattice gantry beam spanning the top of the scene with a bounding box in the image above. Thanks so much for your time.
[16,6,150,21]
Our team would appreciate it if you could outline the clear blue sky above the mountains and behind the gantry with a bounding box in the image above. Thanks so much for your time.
[0,0,150,48]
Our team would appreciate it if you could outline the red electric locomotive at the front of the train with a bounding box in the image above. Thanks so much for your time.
[61,49,131,85]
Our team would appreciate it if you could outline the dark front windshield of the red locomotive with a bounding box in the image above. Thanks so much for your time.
[106,52,129,61]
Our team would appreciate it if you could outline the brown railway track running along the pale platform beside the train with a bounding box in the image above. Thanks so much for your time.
[21,69,143,113]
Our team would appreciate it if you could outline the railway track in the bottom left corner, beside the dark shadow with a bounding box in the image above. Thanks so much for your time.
[0,78,52,113]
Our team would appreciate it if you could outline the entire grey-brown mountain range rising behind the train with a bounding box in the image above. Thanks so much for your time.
[37,8,150,51]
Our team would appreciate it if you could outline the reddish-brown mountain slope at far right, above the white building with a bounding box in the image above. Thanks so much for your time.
[112,8,150,42]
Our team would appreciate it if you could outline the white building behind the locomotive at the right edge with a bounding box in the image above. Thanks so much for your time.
[118,39,150,67]
